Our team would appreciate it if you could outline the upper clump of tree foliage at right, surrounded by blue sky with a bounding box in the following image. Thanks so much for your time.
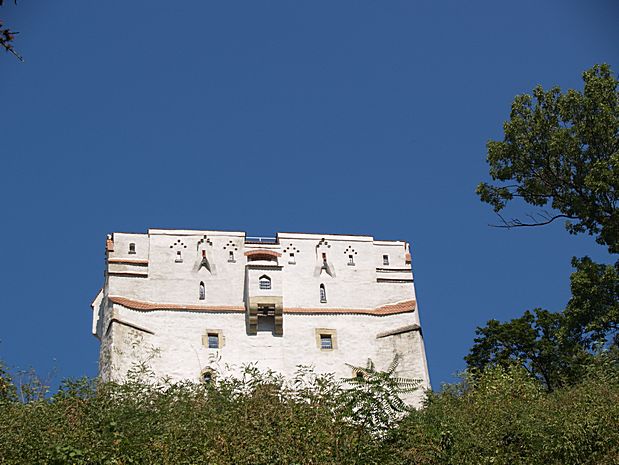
[477,64,619,253]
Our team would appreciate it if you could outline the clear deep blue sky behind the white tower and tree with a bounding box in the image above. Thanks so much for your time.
[0,0,619,388]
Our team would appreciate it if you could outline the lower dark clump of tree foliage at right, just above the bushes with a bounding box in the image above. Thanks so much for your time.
[465,257,619,390]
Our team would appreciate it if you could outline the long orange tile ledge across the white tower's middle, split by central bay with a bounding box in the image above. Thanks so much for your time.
[108,296,417,316]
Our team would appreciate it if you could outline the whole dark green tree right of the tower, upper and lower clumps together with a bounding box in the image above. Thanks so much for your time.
[465,65,619,390]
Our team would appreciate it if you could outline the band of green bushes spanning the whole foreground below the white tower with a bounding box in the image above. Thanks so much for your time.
[0,355,619,465]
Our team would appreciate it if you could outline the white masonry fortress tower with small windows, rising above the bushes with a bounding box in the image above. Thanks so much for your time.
[92,229,430,404]
